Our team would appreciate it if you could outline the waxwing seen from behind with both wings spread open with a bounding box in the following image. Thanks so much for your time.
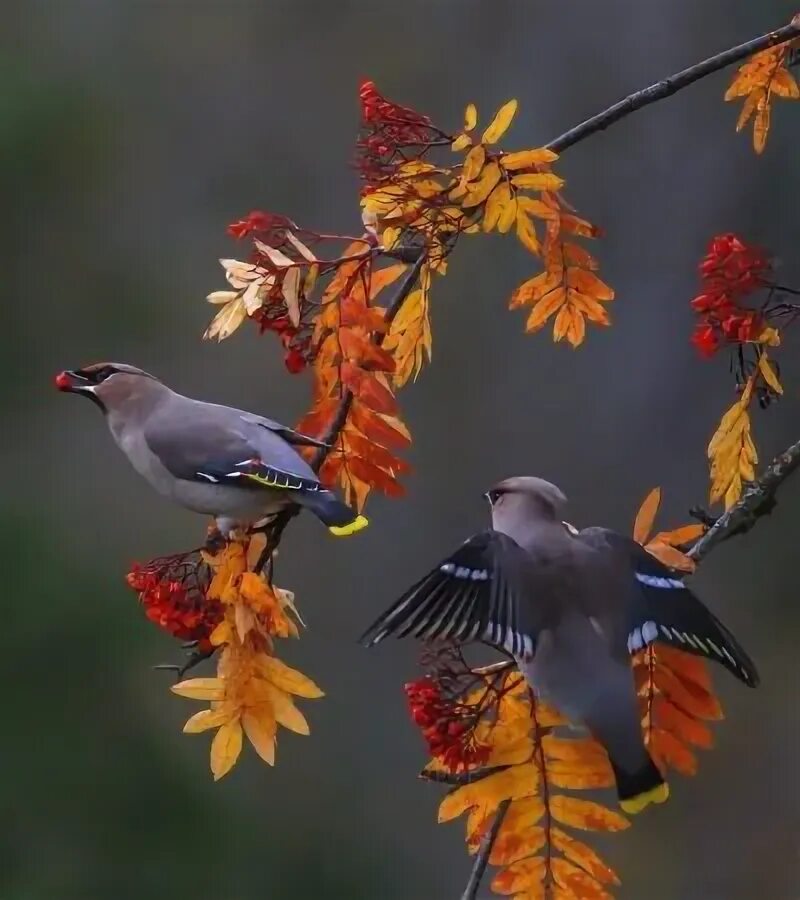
[362,477,758,813]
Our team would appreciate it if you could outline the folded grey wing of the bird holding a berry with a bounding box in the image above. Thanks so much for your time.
[144,402,320,491]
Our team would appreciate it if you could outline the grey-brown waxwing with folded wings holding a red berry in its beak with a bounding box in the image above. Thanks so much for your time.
[56,363,367,536]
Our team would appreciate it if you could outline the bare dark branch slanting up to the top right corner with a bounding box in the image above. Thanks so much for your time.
[547,20,800,153]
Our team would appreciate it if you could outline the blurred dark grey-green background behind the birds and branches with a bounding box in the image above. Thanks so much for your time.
[6,0,800,900]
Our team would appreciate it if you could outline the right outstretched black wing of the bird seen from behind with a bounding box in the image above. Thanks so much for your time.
[578,528,759,687]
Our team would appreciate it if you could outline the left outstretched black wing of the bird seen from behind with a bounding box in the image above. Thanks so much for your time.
[361,530,536,656]
